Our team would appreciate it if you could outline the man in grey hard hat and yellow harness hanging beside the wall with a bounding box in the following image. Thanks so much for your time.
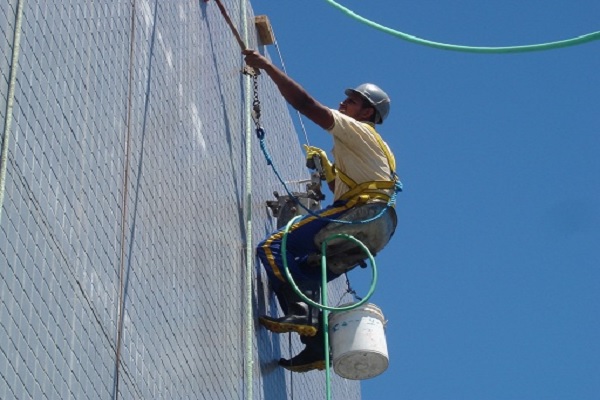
[243,50,398,372]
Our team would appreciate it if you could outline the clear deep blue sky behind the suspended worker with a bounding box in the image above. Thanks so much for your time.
[252,0,600,400]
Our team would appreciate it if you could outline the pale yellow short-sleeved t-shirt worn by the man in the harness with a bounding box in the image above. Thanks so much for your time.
[329,109,393,201]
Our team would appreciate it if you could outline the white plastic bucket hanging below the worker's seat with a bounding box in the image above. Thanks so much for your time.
[329,303,389,380]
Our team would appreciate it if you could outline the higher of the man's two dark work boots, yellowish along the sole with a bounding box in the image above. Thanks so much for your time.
[258,284,320,336]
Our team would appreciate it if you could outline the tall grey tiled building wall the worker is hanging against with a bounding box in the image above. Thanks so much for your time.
[0,0,360,400]
